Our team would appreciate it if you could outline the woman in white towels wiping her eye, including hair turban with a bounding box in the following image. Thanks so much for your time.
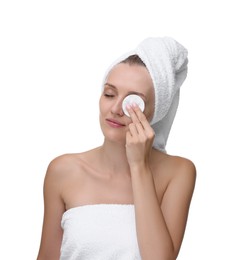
[37,38,196,260]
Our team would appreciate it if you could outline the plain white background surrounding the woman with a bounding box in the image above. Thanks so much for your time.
[0,0,233,260]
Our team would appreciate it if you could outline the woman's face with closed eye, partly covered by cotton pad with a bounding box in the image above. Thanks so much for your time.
[99,63,155,142]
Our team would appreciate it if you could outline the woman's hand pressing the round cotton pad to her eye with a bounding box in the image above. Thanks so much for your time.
[126,104,155,167]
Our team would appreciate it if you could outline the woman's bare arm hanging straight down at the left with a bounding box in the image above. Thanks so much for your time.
[37,159,65,260]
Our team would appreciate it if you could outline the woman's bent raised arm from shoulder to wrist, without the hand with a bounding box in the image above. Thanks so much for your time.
[131,156,195,260]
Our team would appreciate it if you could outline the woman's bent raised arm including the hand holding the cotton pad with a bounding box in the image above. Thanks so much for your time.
[126,104,196,260]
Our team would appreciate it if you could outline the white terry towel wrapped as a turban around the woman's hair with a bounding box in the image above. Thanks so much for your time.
[104,37,188,152]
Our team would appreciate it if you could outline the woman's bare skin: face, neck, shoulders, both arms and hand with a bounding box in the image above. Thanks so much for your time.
[37,64,196,260]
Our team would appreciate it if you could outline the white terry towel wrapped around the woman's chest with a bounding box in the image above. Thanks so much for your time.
[60,204,141,260]
